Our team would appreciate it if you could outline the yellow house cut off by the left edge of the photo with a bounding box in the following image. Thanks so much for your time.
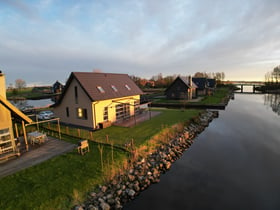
[0,71,32,160]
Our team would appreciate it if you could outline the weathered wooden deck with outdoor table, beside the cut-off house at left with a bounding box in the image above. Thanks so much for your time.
[0,137,77,178]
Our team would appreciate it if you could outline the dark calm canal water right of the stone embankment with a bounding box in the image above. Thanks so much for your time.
[124,94,280,210]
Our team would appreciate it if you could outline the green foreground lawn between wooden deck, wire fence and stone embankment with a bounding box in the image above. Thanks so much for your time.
[0,140,126,209]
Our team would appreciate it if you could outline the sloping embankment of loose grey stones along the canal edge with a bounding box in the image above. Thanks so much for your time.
[74,111,218,210]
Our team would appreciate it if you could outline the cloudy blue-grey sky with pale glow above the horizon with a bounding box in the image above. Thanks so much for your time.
[0,0,280,85]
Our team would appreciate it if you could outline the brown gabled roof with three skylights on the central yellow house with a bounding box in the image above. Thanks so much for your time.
[53,72,143,105]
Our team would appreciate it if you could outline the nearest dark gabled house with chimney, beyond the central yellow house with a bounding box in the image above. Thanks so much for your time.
[165,76,197,100]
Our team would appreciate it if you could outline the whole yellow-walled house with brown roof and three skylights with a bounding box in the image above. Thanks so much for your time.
[53,72,143,129]
